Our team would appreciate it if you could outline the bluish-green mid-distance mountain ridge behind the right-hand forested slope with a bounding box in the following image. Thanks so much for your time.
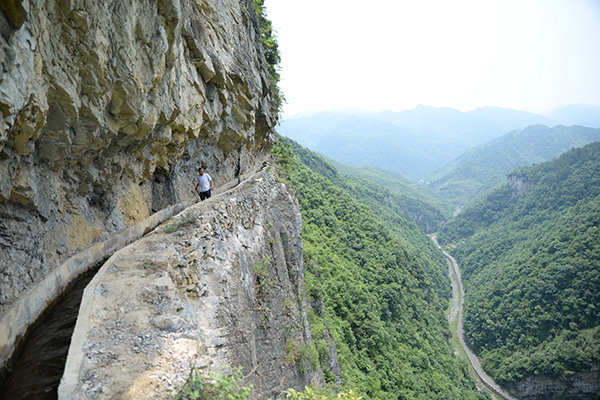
[427,125,600,205]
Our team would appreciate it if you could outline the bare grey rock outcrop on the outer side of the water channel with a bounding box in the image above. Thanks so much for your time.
[59,171,322,399]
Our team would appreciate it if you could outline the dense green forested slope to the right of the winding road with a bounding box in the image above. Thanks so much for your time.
[439,143,600,382]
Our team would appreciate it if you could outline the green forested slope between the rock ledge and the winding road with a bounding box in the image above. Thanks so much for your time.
[273,138,486,400]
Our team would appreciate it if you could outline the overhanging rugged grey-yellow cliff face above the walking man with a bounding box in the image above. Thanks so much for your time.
[0,0,276,364]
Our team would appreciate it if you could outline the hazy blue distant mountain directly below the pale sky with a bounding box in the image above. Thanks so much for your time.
[278,106,559,181]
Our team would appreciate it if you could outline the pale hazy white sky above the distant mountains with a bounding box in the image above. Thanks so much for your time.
[265,0,600,116]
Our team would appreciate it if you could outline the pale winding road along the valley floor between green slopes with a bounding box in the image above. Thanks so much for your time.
[431,235,518,400]
